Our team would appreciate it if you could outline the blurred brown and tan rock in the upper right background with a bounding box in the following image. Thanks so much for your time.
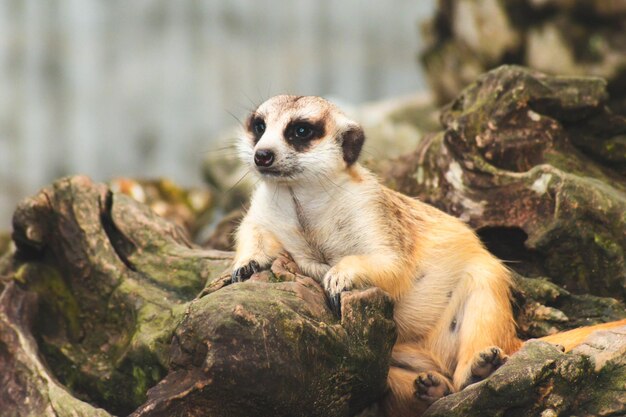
[422,0,626,114]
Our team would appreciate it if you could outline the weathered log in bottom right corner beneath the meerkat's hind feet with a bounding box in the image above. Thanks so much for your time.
[424,327,626,417]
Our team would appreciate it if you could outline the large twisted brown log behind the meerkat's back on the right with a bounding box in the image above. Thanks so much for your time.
[379,66,626,300]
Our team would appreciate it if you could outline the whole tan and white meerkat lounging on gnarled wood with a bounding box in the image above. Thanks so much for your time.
[227,95,620,416]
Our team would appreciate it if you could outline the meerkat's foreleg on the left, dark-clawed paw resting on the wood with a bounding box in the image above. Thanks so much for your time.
[231,216,283,282]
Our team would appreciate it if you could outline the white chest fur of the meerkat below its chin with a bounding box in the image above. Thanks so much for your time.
[248,176,378,279]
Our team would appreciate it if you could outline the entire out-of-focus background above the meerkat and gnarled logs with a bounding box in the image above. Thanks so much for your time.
[0,0,626,231]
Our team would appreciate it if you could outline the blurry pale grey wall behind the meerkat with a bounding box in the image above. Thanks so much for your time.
[0,0,434,230]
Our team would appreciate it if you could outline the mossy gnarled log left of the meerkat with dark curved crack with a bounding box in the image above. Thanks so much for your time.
[4,177,230,414]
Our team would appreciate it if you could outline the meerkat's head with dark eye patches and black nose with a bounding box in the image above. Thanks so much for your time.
[239,95,365,182]
